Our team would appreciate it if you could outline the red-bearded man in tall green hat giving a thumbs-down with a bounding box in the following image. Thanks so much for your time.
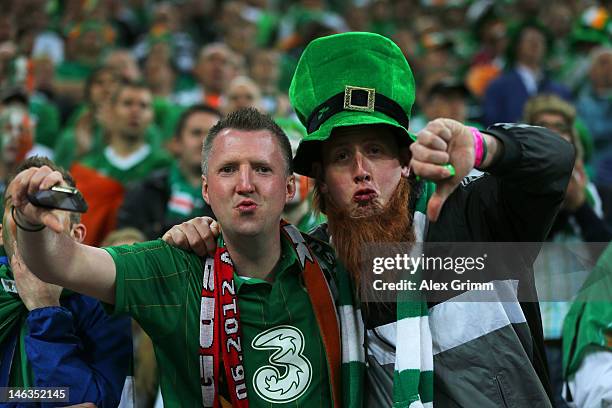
[168,33,574,407]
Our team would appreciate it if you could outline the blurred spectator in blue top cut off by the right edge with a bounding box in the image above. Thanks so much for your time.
[576,47,612,186]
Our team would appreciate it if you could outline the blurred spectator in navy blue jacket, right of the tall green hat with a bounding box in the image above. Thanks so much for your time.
[482,22,570,126]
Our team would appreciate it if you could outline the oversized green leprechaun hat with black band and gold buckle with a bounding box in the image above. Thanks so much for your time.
[289,33,415,177]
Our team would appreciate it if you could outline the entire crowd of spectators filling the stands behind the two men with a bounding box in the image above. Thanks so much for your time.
[0,0,612,406]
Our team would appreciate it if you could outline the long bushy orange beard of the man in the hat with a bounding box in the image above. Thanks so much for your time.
[324,178,415,293]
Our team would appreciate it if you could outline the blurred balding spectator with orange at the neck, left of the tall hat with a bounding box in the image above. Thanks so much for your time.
[175,43,238,109]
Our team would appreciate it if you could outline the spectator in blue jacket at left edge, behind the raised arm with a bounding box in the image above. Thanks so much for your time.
[0,157,132,407]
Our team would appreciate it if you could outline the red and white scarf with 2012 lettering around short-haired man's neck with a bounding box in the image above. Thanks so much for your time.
[199,221,341,408]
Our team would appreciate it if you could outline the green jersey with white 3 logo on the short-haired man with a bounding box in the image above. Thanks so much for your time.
[106,238,331,407]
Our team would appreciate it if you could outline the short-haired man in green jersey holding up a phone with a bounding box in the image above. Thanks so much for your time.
[8,109,346,407]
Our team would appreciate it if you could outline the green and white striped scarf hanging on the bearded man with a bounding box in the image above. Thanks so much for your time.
[309,183,434,408]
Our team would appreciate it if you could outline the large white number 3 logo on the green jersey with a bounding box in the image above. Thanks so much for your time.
[251,326,312,403]
